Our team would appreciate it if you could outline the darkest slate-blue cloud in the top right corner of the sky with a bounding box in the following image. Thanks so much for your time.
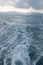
[28,0,43,9]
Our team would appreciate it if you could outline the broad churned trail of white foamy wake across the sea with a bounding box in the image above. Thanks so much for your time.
[0,23,30,65]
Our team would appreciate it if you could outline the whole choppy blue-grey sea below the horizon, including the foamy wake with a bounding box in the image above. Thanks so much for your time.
[0,14,43,65]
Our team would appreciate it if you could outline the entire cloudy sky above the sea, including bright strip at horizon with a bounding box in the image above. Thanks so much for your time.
[0,0,43,13]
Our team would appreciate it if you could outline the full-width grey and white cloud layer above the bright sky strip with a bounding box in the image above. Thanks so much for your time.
[0,0,43,9]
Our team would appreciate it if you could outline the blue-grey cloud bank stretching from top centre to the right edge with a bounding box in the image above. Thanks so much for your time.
[16,0,43,9]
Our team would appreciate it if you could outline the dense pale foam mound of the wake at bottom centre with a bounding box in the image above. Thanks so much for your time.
[12,45,30,65]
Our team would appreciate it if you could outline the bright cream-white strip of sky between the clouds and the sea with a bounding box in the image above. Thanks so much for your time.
[0,6,43,14]
